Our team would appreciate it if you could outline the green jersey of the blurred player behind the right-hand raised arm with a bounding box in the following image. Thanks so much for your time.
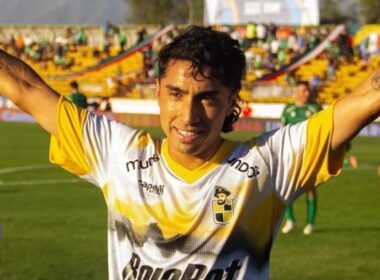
[281,102,322,125]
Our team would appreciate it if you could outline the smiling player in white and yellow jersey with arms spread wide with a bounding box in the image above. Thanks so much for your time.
[0,27,380,279]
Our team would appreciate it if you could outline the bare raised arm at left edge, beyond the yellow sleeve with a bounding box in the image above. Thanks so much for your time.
[0,50,59,135]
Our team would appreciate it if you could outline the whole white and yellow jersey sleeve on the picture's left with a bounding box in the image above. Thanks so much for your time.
[49,98,134,187]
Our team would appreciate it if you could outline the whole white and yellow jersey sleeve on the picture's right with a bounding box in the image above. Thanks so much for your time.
[257,106,343,202]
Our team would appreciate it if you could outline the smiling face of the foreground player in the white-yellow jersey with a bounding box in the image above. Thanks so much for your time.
[157,60,236,165]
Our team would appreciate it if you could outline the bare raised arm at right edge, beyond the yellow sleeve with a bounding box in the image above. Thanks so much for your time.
[332,69,380,152]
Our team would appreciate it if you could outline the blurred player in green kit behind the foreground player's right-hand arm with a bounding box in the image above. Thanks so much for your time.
[281,81,322,235]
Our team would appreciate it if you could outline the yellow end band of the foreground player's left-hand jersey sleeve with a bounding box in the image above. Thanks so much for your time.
[49,97,90,175]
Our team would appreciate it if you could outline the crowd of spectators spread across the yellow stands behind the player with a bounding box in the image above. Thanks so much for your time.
[0,21,380,105]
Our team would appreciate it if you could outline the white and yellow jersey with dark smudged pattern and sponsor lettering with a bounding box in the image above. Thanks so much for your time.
[50,98,340,280]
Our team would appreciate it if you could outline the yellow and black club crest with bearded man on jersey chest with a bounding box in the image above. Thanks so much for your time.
[212,186,234,225]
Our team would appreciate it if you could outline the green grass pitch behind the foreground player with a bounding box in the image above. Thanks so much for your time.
[0,123,380,280]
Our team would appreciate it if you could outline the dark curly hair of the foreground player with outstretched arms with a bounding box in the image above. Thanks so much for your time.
[158,26,245,132]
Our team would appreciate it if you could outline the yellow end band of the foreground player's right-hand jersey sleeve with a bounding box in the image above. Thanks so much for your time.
[300,105,344,188]
